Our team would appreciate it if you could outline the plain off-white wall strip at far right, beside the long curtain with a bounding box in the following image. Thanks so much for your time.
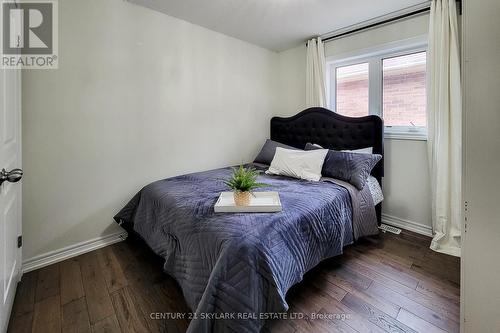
[462,0,500,333]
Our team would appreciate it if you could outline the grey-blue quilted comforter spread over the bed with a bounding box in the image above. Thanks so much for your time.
[115,164,377,332]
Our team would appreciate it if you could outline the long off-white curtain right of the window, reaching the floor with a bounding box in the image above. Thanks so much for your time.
[428,0,462,256]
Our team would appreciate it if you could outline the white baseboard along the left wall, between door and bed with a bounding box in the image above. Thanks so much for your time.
[22,231,127,273]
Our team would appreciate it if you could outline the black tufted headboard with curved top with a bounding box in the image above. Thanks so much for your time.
[271,107,384,225]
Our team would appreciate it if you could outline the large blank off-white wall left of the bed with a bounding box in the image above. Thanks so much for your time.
[23,0,278,260]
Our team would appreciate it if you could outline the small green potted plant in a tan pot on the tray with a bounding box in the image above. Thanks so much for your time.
[224,165,268,206]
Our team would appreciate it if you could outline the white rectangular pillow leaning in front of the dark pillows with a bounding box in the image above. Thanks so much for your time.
[266,147,328,182]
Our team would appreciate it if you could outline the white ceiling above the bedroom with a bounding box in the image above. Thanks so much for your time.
[128,0,424,51]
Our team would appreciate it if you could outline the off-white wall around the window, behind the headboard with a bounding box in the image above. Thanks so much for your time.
[277,15,432,232]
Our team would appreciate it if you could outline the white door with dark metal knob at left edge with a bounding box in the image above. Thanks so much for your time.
[0,14,21,332]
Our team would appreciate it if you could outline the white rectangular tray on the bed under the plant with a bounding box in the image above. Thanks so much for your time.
[214,192,281,213]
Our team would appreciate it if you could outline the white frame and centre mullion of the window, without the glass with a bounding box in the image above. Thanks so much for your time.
[326,35,428,141]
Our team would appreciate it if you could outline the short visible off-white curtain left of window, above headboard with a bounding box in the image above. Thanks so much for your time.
[306,37,326,107]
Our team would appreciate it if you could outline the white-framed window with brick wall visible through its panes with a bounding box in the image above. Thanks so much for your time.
[328,39,427,140]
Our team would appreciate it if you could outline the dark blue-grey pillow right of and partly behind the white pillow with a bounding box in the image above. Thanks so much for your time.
[305,143,382,190]
